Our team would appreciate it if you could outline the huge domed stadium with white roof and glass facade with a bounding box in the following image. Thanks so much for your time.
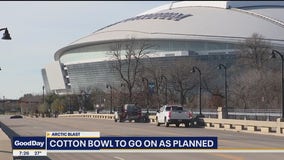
[42,1,284,94]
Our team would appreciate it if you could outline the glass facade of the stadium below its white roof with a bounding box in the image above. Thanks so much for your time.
[56,40,236,93]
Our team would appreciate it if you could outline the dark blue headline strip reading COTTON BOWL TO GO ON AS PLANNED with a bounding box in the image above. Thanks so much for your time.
[46,137,218,151]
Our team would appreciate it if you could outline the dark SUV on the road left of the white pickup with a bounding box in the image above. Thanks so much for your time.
[114,104,149,122]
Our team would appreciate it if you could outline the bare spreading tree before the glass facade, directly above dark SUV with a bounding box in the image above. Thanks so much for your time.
[110,39,154,103]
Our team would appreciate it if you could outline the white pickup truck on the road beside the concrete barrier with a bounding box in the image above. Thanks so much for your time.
[156,105,192,127]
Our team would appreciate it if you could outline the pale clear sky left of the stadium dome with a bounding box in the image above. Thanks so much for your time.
[0,1,170,99]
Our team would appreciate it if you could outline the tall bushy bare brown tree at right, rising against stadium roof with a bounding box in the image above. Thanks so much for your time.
[230,33,280,109]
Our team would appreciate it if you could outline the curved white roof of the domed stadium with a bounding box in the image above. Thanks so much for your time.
[54,1,284,60]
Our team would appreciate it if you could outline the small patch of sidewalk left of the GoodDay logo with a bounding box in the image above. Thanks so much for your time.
[0,128,13,160]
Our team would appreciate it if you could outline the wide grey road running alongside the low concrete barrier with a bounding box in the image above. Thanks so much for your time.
[0,117,284,160]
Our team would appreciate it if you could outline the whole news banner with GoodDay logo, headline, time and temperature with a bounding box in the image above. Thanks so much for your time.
[12,131,218,156]
